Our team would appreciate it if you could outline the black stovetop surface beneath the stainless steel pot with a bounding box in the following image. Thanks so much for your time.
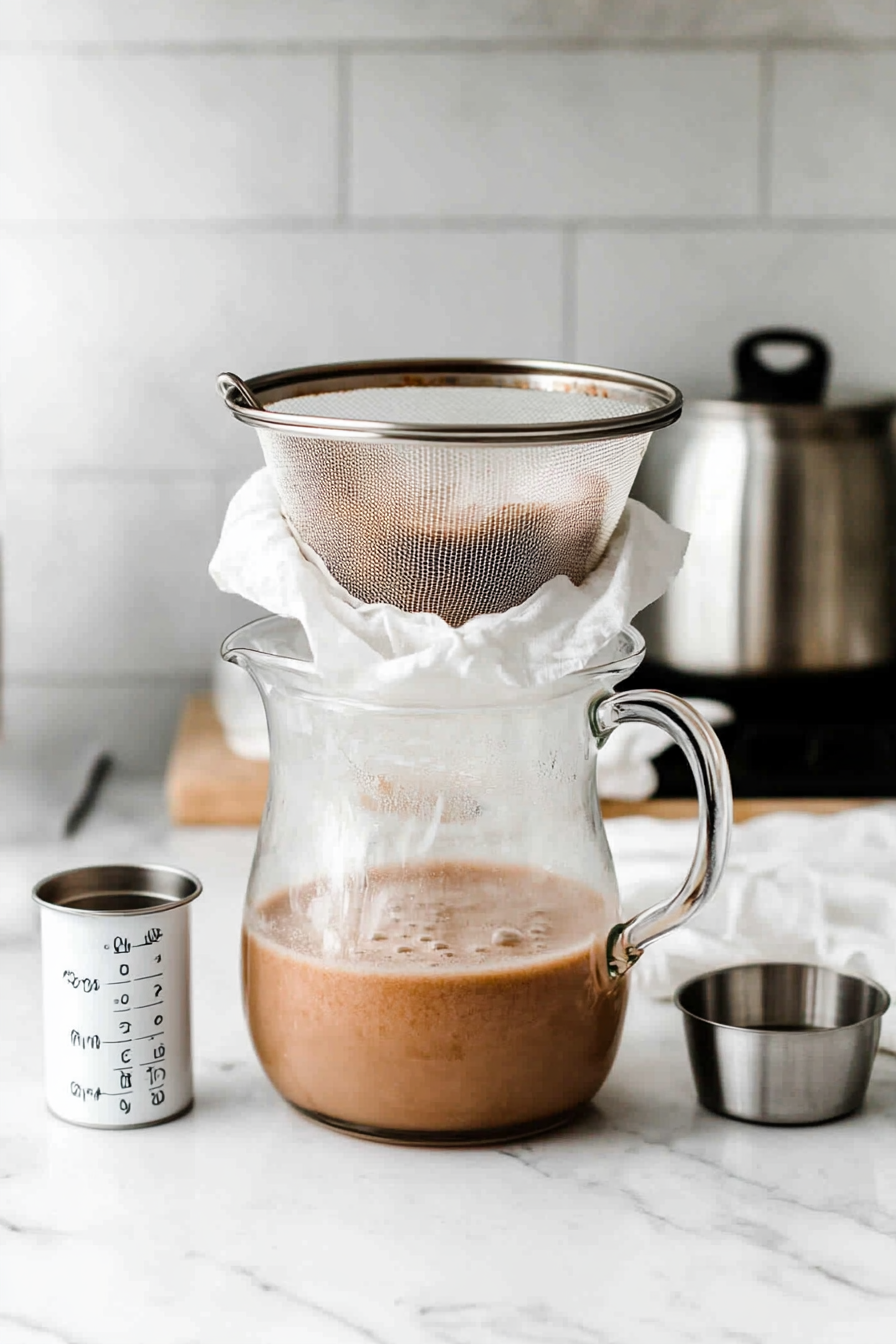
[626,663,896,798]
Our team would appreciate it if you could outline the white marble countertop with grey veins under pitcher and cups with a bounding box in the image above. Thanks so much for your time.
[0,781,896,1344]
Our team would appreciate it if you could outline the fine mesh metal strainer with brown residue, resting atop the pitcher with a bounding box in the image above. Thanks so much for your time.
[218,359,681,626]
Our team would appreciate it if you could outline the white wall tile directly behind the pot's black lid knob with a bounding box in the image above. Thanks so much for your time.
[576,227,896,396]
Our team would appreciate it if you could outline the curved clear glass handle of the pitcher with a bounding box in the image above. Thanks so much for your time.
[588,691,732,977]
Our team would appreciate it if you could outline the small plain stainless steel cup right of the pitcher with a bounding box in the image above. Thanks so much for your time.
[674,962,889,1125]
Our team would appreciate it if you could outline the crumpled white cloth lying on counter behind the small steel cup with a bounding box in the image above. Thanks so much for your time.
[607,802,896,1052]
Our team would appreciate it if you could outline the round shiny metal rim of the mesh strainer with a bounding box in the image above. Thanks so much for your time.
[218,359,682,446]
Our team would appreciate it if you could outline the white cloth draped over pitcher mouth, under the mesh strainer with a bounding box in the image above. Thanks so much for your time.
[210,469,688,703]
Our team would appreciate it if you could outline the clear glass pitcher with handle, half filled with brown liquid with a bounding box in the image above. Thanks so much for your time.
[222,617,731,1144]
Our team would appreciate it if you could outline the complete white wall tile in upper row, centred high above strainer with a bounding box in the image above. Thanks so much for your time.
[351,51,759,216]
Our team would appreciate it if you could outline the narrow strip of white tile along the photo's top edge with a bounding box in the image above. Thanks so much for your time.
[0,0,896,42]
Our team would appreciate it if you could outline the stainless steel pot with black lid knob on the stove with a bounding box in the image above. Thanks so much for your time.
[633,328,896,675]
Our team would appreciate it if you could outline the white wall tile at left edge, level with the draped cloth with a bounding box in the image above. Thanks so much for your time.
[3,472,222,679]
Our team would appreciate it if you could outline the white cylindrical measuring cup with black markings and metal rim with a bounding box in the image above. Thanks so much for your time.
[34,864,201,1129]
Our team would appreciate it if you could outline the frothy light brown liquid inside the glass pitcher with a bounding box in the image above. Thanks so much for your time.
[243,863,627,1138]
